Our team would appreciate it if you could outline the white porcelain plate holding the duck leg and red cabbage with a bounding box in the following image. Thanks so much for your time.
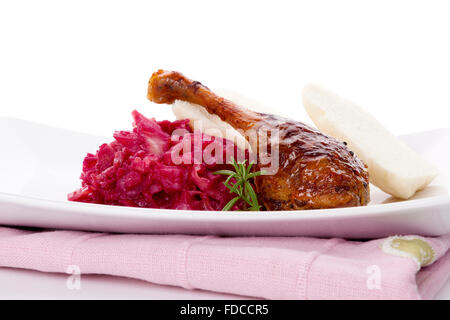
[0,118,450,238]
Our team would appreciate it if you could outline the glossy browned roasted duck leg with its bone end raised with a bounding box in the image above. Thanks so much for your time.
[147,70,369,210]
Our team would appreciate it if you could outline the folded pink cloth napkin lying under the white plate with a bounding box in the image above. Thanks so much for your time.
[0,227,450,299]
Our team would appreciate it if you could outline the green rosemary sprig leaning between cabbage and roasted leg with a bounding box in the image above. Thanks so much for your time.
[214,158,263,211]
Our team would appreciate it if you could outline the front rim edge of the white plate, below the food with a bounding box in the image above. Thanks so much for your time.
[0,192,450,221]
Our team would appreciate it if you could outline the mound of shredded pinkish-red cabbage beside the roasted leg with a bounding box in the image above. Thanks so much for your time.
[68,111,248,210]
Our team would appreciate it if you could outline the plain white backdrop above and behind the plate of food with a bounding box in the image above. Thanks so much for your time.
[0,0,450,298]
